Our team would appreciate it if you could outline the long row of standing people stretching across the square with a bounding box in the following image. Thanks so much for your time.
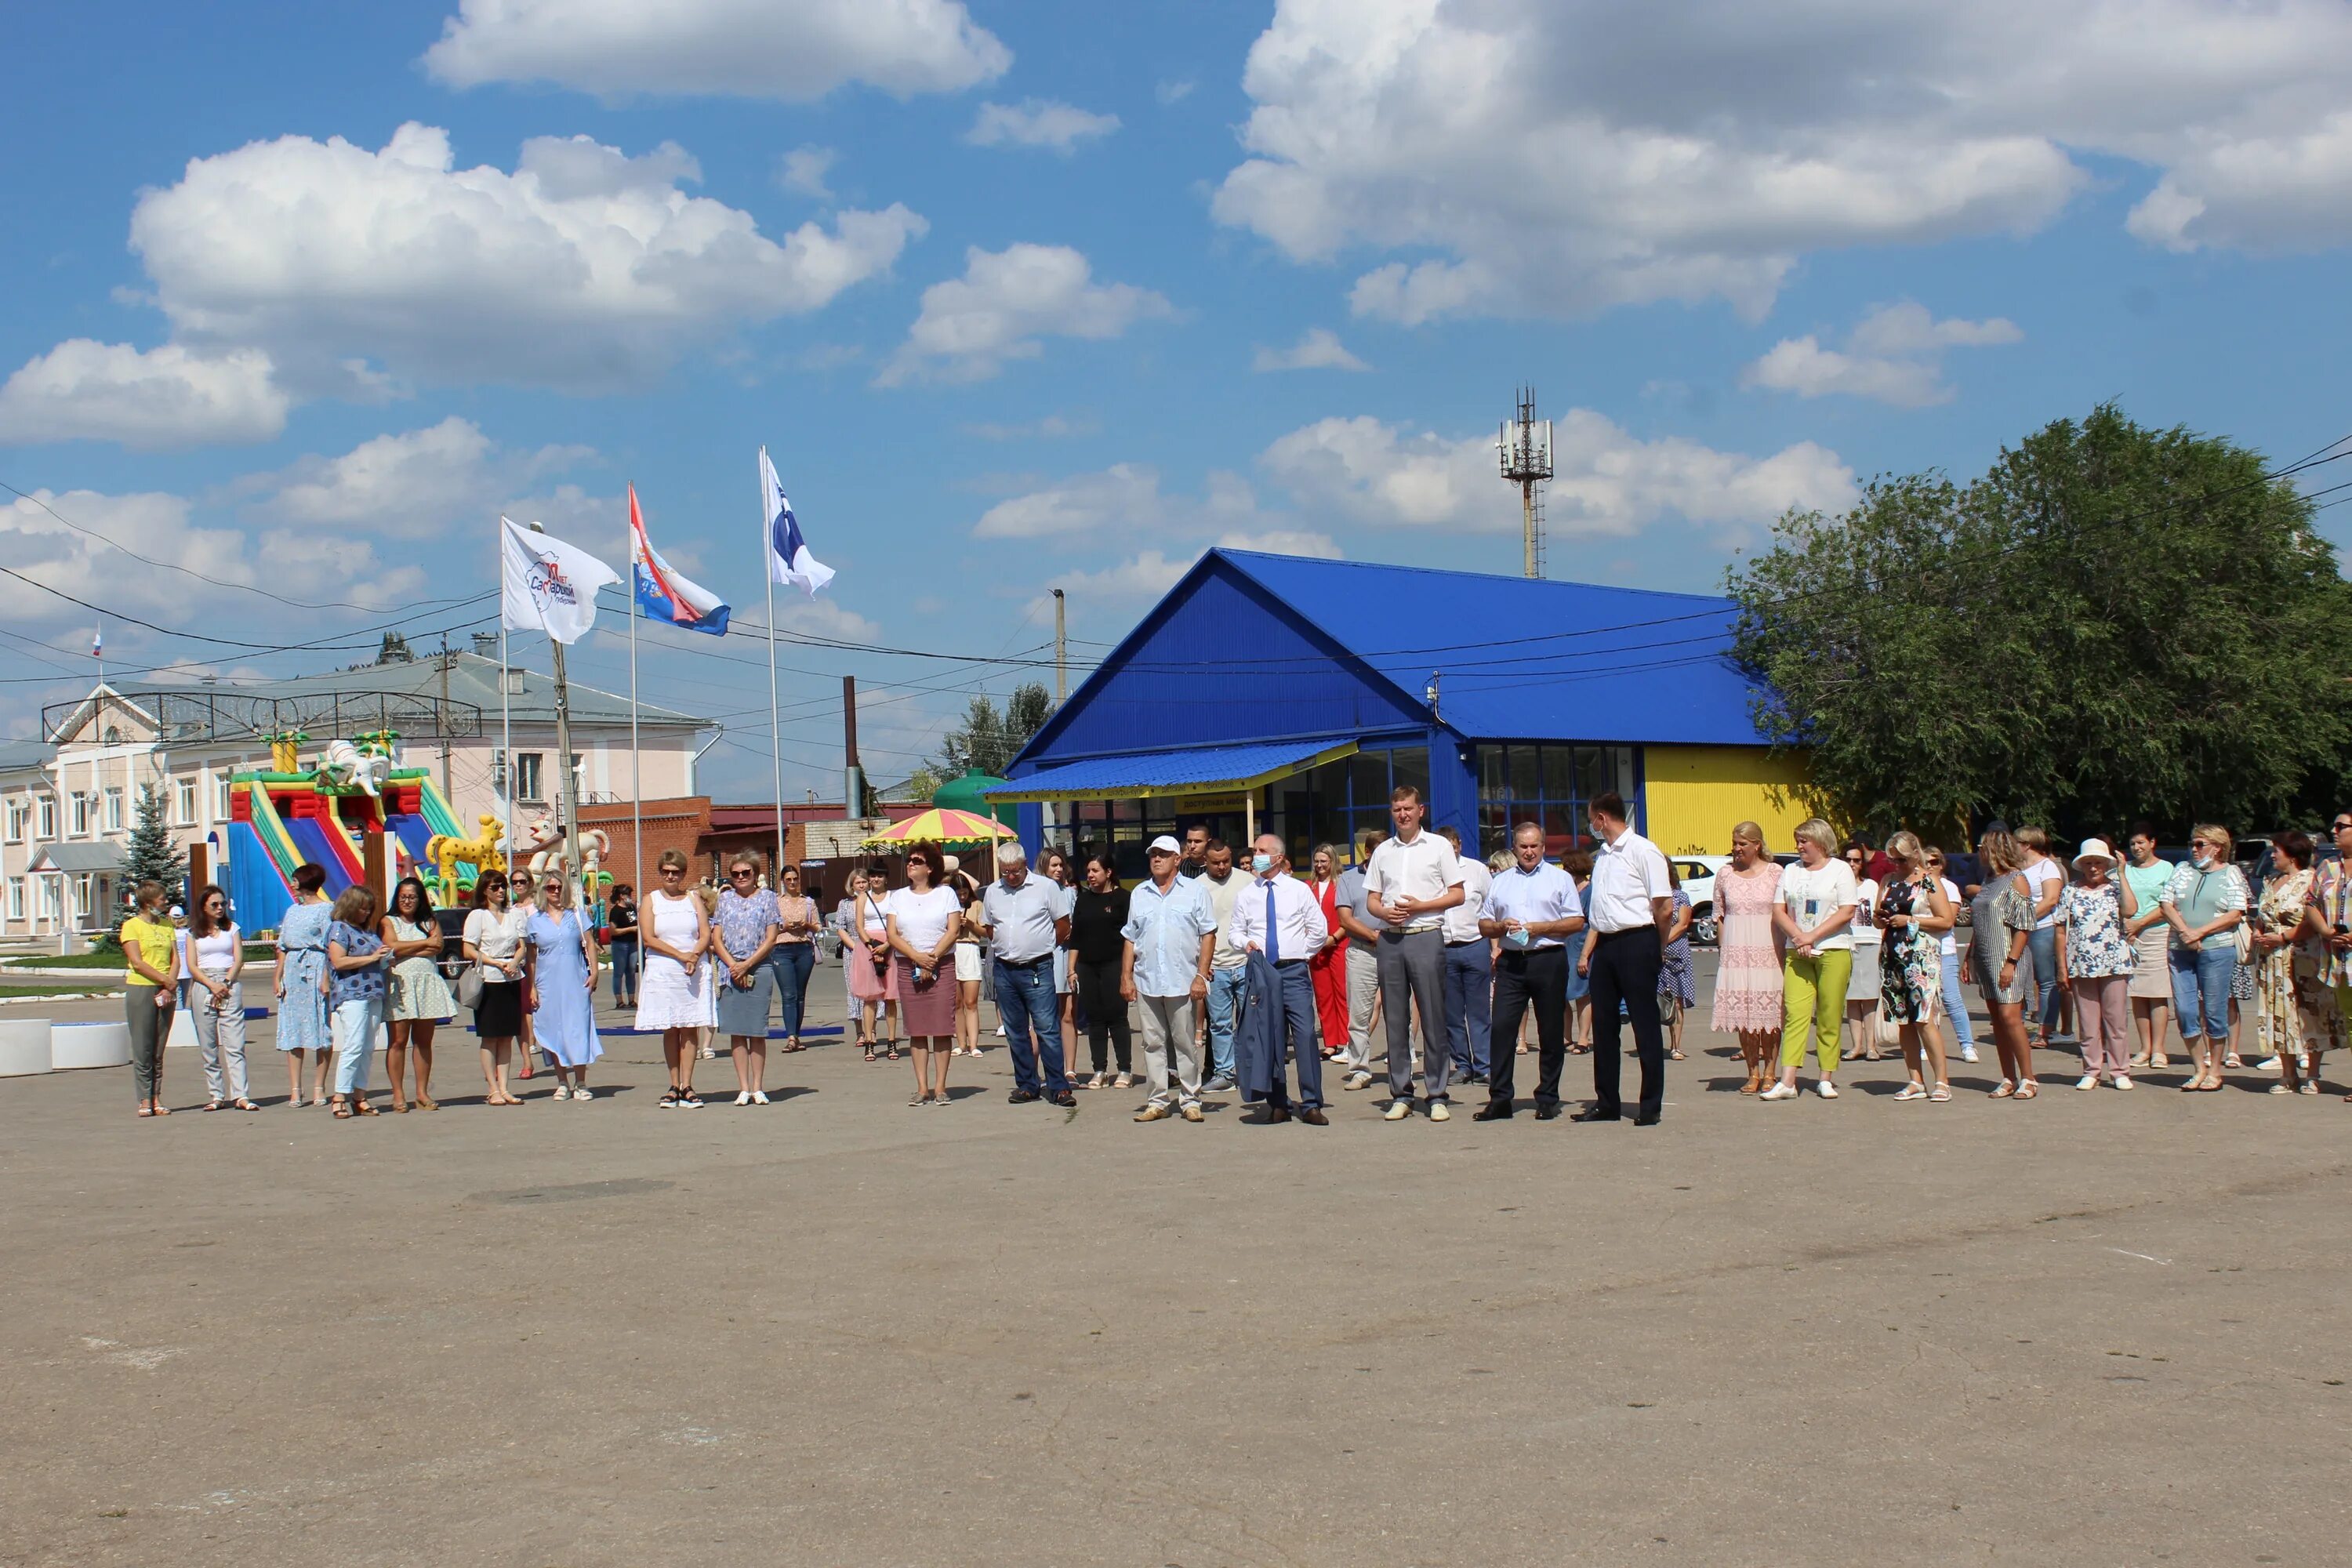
[120,785,2352,1126]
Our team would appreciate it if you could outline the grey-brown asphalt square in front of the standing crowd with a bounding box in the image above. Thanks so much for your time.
[0,971,2352,1568]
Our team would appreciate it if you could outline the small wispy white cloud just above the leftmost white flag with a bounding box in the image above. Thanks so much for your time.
[245,414,597,536]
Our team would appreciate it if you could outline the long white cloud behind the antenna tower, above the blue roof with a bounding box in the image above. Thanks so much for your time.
[1258,409,1856,536]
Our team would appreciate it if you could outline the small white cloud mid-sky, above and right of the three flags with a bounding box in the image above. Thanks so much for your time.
[880,245,1174,386]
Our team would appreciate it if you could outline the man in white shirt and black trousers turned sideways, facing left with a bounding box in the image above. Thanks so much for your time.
[1571,789,1675,1126]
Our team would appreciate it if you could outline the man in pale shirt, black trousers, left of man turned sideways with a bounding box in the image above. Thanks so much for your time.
[1477,822,1585,1121]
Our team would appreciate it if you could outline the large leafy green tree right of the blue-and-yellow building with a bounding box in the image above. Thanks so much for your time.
[1729,405,2352,832]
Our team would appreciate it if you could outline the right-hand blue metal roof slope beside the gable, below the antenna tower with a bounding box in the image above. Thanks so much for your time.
[1204,550,1764,746]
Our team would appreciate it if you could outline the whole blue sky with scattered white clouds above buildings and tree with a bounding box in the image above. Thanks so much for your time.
[0,0,2352,797]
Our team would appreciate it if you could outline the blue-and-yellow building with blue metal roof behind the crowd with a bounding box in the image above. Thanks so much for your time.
[990,550,1813,877]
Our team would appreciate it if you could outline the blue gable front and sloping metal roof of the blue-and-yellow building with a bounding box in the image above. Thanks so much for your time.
[1007,550,1766,781]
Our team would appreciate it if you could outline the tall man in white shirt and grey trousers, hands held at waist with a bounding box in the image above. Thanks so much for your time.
[1364,785,1463,1121]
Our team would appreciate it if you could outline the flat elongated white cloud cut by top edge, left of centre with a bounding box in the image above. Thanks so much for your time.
[426,0,1014,101]
